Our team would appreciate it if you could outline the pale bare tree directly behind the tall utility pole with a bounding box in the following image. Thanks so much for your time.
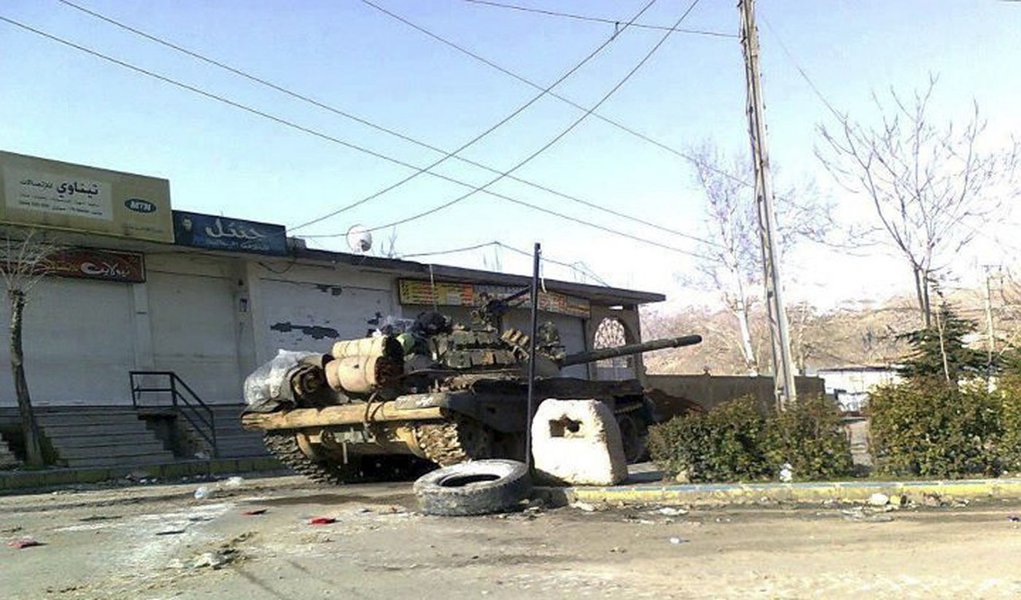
[689,143,831,374]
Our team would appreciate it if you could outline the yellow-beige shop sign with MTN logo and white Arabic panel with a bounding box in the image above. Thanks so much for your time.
[0,152,173,242]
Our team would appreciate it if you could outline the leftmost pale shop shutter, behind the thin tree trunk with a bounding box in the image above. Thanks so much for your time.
[0,278,136,406]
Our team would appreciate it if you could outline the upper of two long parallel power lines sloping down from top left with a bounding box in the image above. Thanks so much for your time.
[57,0,719,246]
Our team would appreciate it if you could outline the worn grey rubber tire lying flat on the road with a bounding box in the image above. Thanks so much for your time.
[414,459,532,516]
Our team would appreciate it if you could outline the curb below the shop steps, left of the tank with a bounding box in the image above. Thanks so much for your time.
[0,456,285,496]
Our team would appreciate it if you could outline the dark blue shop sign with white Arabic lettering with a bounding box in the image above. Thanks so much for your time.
[174,210,287,256]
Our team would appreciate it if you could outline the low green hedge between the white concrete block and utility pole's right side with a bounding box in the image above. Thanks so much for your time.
[649,397,852,482]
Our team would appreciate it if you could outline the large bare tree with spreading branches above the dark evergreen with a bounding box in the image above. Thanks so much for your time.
[816,76,1021,328]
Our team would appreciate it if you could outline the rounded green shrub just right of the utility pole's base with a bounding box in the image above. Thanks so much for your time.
[766,396,854,480]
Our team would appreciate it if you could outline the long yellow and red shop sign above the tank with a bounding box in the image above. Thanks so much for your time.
[399,280,591,318]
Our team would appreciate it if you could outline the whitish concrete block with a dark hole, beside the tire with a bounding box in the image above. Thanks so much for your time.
[532,398,628,486]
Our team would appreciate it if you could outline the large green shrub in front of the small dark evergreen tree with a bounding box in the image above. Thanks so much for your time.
[869,379,1003,478]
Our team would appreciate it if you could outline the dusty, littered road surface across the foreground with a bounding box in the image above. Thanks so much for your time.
[0,478,1021,600]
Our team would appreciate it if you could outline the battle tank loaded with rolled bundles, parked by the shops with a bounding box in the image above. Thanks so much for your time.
[242,299,701,484]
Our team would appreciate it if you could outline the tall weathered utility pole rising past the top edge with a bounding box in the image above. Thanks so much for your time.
[737,0,797,410]
